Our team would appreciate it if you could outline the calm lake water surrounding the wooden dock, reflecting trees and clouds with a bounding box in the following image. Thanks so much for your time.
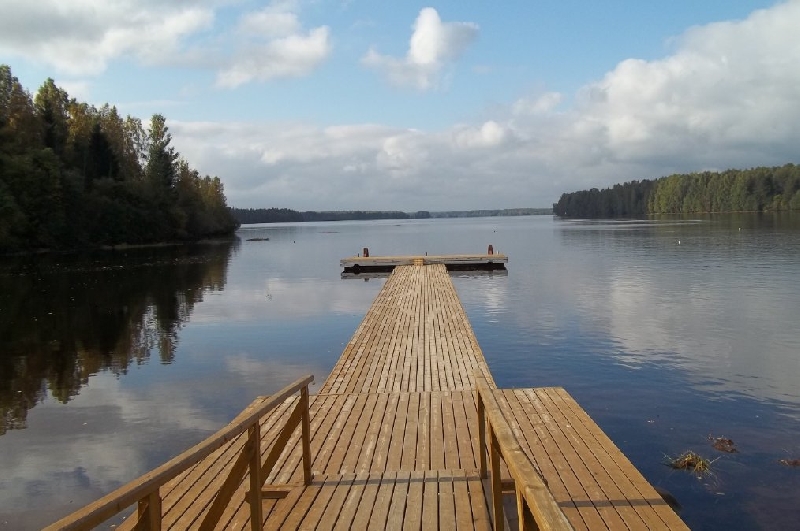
[0,214,800,530]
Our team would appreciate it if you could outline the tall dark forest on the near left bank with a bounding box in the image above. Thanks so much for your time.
[0,65,237,252]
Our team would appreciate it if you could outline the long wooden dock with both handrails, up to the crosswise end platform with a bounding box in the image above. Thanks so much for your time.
[49,264,686,530]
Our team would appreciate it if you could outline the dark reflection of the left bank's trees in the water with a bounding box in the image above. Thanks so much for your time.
[0,241,238,435]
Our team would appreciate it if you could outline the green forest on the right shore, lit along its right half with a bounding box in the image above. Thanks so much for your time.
[553,164,800,218]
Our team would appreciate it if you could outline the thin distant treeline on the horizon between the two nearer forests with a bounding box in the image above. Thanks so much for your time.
[230,208,550,224]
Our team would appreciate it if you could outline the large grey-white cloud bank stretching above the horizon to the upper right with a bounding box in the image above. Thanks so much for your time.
[170,1,800,210]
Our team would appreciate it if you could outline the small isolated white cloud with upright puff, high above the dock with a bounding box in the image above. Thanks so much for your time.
[361,7,478,90]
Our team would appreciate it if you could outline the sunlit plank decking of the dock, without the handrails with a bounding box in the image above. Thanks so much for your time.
[121,265,685,530]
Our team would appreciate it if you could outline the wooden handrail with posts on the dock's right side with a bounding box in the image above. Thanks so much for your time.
[475,374,572,531]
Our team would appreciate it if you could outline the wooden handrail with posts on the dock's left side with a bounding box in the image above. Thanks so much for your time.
[45,375,314,531]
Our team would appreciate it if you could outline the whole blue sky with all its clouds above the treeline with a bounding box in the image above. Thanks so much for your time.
[0,0,800,210]
